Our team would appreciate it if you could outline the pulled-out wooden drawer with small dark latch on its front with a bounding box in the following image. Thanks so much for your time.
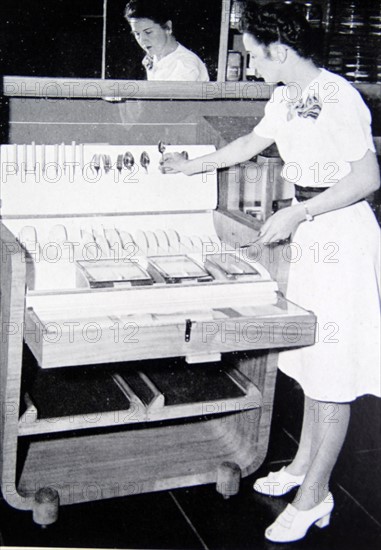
[24,297,316,368]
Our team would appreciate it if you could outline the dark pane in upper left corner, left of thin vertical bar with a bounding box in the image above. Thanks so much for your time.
[0,0,103,78]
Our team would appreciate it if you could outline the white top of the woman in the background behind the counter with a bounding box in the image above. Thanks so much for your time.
[146,44,209,82]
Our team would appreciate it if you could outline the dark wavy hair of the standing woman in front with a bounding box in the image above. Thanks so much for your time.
[240,2,316,58]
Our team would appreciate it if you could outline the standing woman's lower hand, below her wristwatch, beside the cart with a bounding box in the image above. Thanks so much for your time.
[259,204,305,244]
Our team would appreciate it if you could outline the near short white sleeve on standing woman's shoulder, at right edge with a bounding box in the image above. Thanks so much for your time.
[318,79,375,162]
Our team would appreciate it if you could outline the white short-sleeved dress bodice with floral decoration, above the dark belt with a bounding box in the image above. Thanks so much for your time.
[254,69,375,187]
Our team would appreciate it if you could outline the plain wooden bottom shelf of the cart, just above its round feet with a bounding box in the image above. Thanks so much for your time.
[18,409,263,505]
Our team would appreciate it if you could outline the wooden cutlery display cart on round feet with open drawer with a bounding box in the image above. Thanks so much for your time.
[0,144,315,525]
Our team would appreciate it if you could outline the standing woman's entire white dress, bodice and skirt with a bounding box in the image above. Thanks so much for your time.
[254,69,381,402]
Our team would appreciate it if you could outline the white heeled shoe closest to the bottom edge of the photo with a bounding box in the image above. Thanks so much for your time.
[265,493,334,542]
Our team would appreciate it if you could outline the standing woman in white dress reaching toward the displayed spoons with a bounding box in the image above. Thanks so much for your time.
[163,3,381,542]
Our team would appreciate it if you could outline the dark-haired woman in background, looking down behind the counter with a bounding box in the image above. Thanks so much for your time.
[124,0,209,82]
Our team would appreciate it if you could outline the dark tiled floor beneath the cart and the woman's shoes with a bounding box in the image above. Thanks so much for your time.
[0,374,381,550]
